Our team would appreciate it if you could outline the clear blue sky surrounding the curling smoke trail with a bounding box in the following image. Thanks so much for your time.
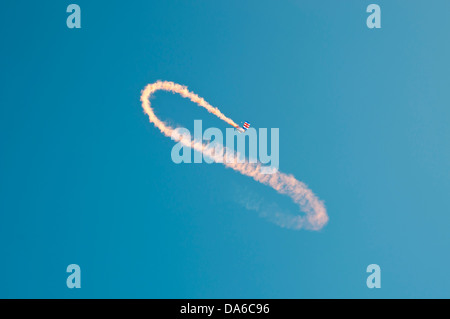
[0,0,450,298]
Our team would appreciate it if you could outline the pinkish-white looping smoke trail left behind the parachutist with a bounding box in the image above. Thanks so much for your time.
[141,81,328,230]
